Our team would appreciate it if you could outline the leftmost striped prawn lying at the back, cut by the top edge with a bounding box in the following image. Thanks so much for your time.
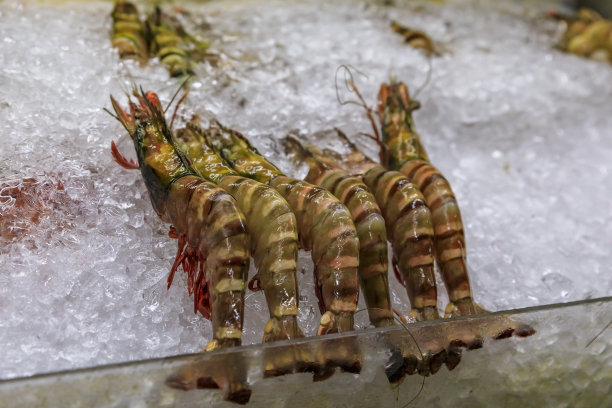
[111,1,148,65]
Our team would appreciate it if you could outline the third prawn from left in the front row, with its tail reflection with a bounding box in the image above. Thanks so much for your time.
[207,122,361,379]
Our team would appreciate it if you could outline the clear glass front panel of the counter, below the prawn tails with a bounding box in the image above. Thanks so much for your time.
[0,298,612,408]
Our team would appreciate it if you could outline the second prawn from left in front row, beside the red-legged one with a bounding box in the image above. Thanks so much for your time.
[176,120,304,348]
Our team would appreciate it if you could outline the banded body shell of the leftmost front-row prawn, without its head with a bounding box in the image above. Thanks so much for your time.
[167,176,250,345]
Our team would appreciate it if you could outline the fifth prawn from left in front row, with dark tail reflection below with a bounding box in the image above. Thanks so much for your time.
[309,129,450,376]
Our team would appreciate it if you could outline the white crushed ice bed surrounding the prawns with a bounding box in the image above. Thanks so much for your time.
[0,2,612,378]
